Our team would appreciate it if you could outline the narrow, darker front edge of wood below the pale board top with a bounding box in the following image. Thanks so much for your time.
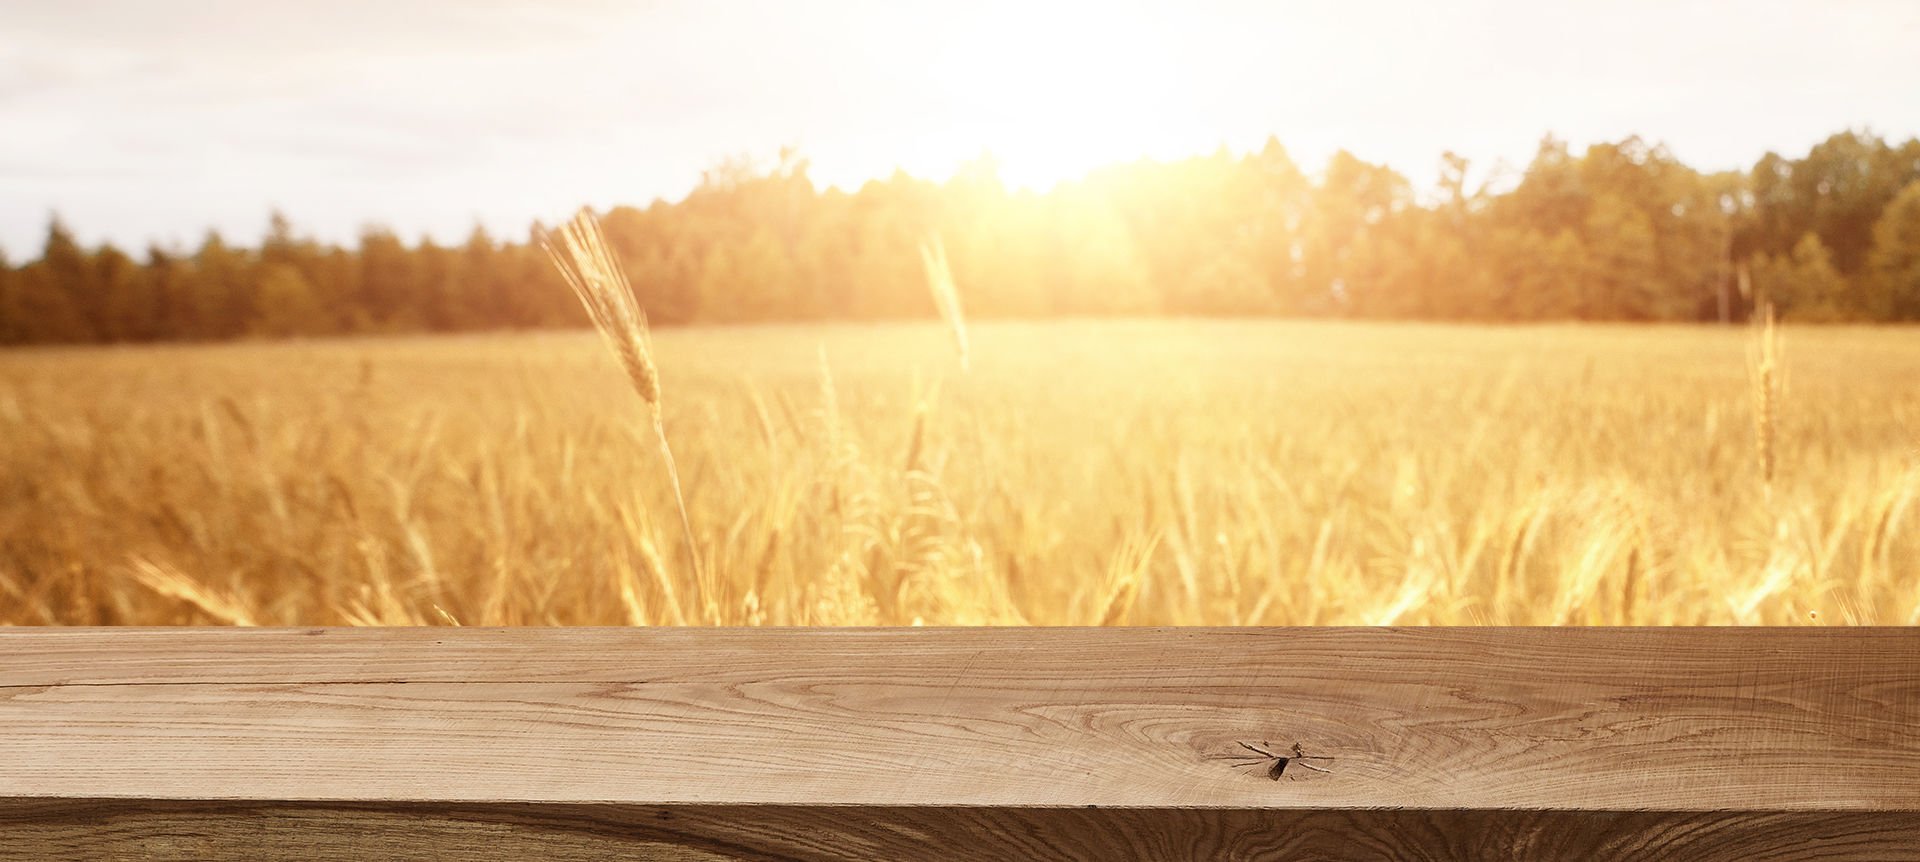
[0,801,1920,862]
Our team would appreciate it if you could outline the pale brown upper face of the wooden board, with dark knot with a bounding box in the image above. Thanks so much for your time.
[0,628,1920,810]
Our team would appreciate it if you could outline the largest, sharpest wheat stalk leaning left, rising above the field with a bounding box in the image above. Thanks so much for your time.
[540,209,707,607]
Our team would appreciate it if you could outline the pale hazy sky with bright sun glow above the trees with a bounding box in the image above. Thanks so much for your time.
[0,0,1920,255]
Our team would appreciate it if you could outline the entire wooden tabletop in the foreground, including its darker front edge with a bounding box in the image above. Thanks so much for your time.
[0,628,1920,858]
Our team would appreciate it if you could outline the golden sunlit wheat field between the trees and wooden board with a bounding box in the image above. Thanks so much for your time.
[0,321,1920,626]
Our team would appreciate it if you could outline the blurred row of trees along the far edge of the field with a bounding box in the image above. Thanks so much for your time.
[0,131,1920,344]
